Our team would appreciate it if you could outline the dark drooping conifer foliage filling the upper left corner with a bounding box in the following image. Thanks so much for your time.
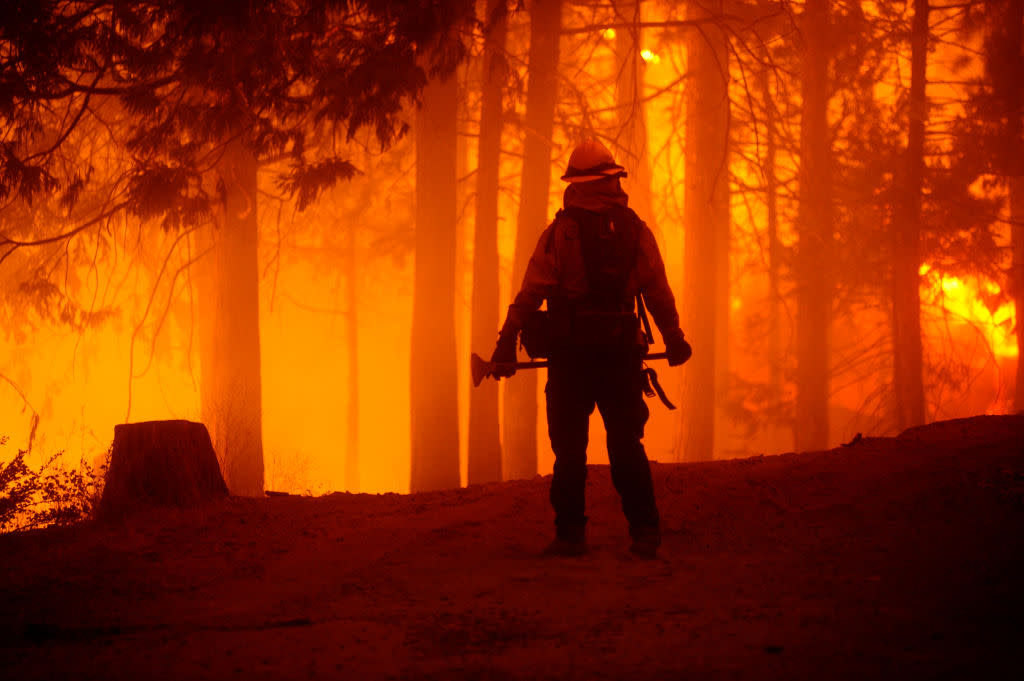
[0,0,473,219]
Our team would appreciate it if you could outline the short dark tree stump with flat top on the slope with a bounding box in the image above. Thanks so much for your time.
[97,421,227,520]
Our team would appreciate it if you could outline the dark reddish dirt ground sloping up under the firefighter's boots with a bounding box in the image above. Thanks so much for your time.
[0,415,1024,681]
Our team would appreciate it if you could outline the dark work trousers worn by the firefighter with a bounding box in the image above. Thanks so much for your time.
[545,350,658,539]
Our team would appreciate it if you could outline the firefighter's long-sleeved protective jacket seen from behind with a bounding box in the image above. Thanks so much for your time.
[501,182,679,348]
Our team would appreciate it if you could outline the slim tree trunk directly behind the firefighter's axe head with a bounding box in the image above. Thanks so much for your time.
[466,0,508,484]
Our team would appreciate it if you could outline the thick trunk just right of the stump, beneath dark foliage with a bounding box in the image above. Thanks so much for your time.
[200,140,263,497]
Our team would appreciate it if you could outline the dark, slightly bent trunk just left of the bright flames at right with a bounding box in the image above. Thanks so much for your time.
[892,0,928,430]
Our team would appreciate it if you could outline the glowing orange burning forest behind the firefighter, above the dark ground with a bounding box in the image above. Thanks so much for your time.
[0,0,1024,503]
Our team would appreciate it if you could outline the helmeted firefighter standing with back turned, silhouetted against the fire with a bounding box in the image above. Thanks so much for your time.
[492,139,692,557]
